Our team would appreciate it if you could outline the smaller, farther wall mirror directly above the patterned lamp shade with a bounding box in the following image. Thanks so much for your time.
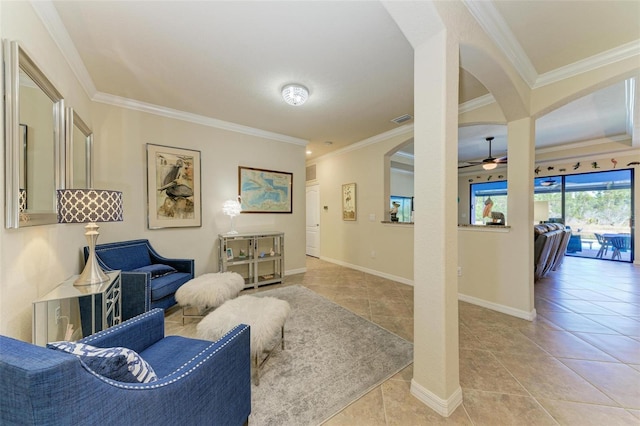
[66,108,93,188]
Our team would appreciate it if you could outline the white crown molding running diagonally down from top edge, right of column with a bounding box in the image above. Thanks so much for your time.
[463,0,538,87]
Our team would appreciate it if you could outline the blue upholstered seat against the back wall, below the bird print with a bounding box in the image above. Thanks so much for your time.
[84,240,194,320]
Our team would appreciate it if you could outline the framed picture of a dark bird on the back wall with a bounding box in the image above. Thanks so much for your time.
[147,144,202,229]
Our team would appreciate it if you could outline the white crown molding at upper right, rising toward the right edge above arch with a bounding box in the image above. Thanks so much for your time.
[532,40,640,89]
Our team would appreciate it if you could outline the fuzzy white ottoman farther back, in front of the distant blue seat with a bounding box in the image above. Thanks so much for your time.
[176,272,244,324]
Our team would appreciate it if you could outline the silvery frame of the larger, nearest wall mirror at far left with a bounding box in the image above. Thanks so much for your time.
[3,40,65,228]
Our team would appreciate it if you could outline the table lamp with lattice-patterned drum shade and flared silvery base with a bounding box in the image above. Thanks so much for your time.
[56,189,122,286]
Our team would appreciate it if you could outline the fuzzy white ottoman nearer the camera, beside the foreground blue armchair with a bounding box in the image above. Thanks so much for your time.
[196,296,291,385]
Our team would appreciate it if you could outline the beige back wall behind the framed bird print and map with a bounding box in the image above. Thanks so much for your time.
[90,103,305,275]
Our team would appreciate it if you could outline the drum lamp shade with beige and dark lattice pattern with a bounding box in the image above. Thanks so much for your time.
[57,189,122,223]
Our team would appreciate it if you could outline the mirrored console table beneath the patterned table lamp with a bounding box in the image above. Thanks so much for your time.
[33,271,122,346]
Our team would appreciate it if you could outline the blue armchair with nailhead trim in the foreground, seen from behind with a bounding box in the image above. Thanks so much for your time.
[0,309,251,426]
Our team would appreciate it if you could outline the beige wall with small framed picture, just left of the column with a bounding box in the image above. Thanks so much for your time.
[309,132,413,283]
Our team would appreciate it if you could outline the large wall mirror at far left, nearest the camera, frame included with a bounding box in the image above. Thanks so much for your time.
[3,41,65,228]
